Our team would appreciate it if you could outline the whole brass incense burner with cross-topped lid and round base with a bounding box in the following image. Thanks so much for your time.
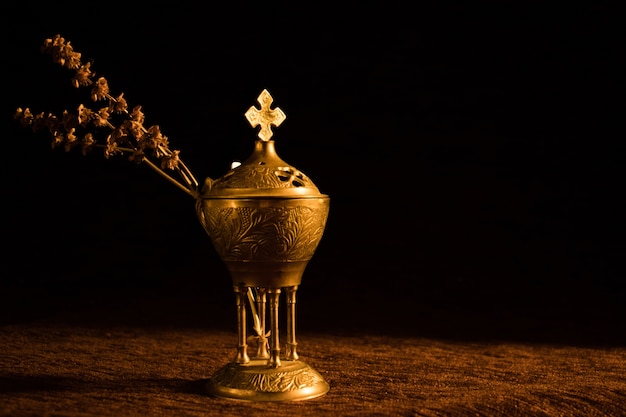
[196,90,330,401]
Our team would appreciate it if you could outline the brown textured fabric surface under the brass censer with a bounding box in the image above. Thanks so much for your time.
[0,302,626,417]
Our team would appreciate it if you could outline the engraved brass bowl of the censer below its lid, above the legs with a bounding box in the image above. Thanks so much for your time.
[200,197,329,288]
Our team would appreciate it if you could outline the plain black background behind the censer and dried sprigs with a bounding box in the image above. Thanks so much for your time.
[0,2,626,344]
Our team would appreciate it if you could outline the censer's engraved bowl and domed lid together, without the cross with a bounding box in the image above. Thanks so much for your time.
[197,141,330,288]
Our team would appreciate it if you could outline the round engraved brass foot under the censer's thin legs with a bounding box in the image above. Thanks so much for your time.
[206,359,330,401]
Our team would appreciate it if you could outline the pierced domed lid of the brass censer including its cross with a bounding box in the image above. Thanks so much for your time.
[200,90,324,198]
